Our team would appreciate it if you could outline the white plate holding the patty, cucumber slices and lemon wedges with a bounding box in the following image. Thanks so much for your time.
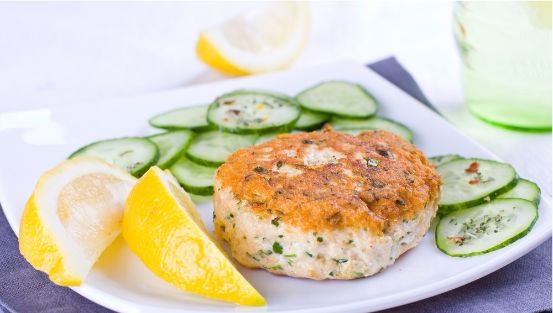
[0,62,551,312]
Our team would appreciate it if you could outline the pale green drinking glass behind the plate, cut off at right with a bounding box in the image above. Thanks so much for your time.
[454,1,552,131]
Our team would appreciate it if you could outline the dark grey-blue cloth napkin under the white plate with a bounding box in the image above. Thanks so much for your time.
[0,57,551,313]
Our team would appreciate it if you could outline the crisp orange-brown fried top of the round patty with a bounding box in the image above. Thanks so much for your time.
[216,130,440,233]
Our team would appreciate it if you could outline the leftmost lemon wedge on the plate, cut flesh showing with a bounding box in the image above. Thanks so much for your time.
[19,157,136,286]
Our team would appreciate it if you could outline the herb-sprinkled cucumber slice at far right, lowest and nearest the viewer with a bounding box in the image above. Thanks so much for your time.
[436,199,538,257]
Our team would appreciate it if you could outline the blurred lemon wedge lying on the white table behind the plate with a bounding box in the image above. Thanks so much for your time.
[196,1,309,75]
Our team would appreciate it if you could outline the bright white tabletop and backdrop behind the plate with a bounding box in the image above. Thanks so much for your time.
[0,1,551,197]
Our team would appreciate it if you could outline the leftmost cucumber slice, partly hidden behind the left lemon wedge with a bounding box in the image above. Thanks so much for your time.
[68,137,159,177]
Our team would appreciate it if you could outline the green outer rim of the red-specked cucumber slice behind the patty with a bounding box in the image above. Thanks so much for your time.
[207,89,301,135]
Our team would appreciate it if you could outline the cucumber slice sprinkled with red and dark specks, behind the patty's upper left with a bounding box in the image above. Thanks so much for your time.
[207,90,300,134]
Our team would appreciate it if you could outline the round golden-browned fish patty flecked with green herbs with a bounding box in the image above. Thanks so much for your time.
[214,129,441,279]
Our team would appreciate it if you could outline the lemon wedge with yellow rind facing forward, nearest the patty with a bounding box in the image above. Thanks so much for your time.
[122,167,265,305]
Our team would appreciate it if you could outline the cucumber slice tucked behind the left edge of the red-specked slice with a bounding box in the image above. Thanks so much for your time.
[148,104,210,130]
